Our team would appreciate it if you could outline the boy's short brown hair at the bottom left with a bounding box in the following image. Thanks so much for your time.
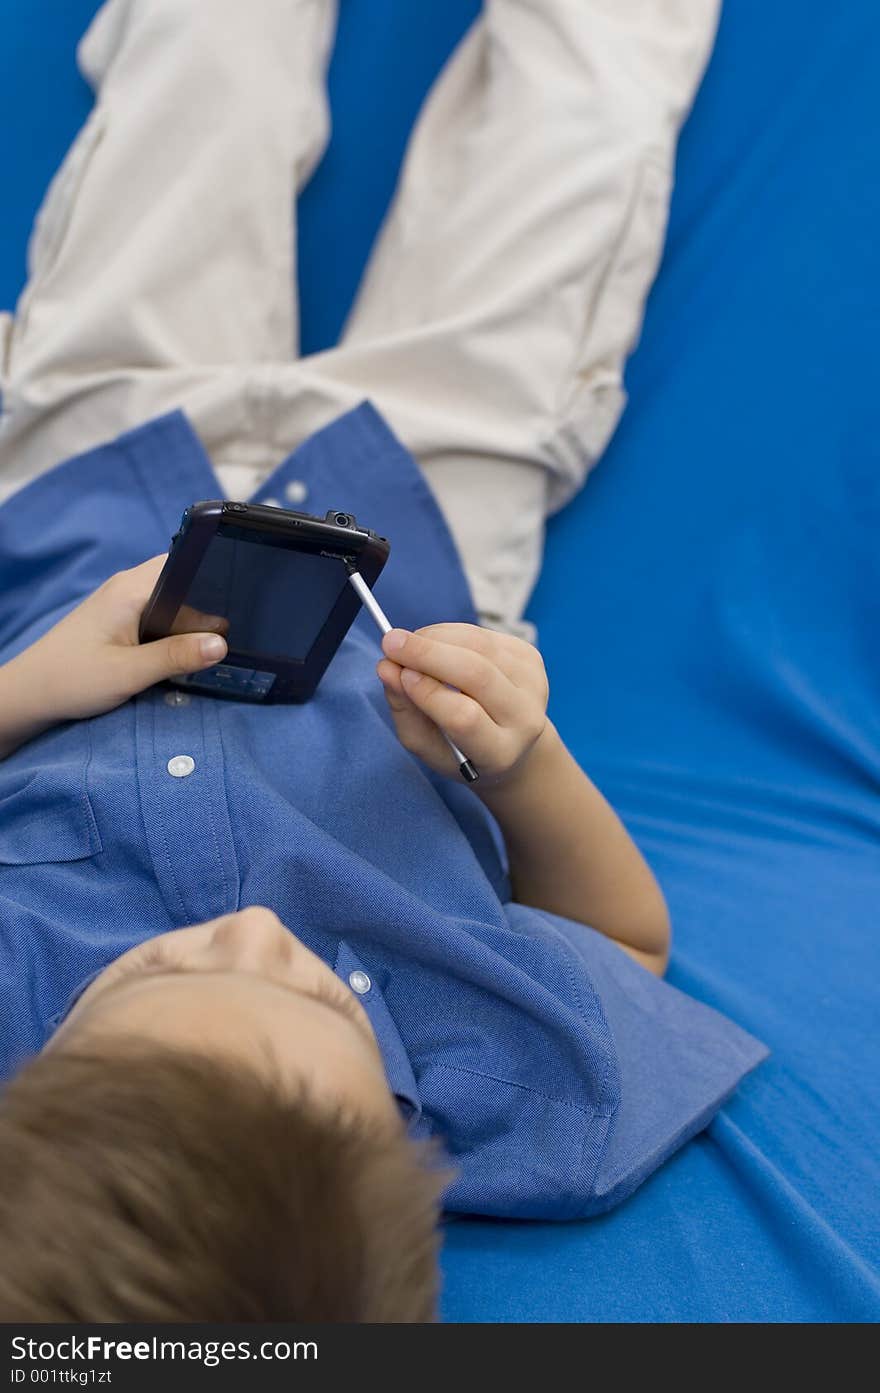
[0,1042,448,1322]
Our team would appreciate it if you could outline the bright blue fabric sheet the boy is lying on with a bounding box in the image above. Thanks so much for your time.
[0,0,880,1321]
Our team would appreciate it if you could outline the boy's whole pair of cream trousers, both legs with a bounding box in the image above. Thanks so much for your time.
[0,0,718,627]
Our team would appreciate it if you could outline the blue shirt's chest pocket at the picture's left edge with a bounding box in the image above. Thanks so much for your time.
[0,722,103,866]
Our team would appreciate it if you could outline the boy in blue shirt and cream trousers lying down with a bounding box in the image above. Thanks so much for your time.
[0,0,763,1321]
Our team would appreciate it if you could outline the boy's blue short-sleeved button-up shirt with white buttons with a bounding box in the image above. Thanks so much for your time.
[0,405,766,1219]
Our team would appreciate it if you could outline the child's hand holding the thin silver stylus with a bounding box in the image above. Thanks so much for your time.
[376,624,549,791]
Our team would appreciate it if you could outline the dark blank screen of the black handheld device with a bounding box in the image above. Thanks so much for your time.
[173,527,348,660]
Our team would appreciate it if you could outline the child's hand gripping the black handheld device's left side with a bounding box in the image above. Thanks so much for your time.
[7,556,227,726]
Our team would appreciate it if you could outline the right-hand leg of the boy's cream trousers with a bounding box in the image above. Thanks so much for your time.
[288,0,718,620]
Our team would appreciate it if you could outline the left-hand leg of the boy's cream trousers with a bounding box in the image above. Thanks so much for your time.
[0,0,336,493]
